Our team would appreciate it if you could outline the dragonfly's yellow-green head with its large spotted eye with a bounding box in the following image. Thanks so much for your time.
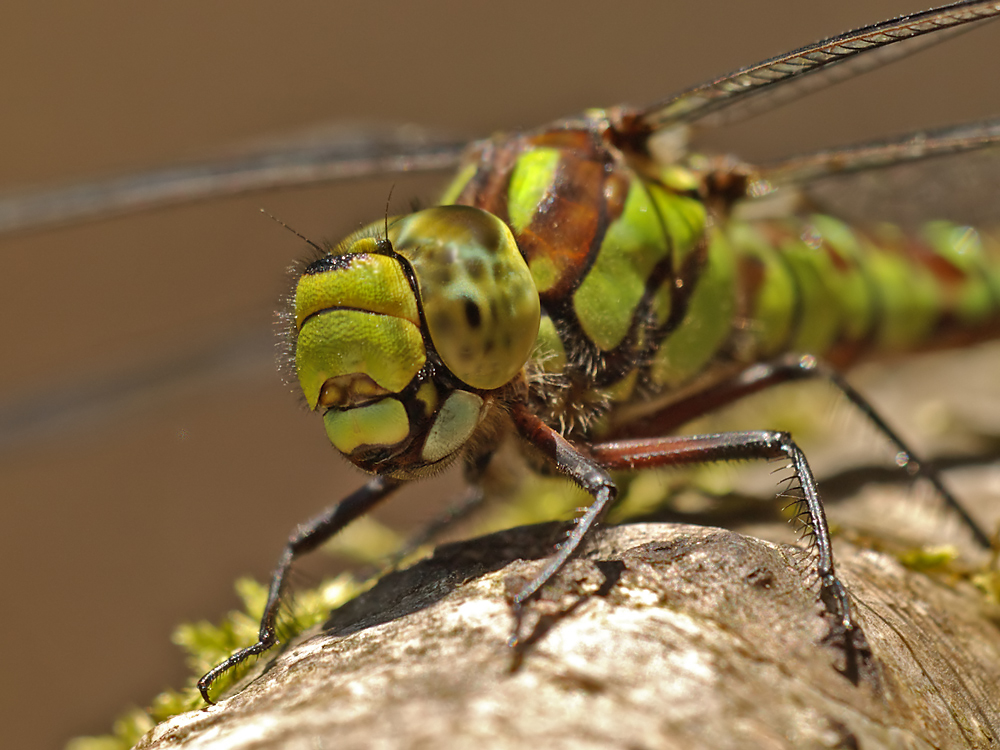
[293,206,540,479]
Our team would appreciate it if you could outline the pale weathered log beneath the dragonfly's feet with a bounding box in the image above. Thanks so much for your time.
[138,524,1000,750]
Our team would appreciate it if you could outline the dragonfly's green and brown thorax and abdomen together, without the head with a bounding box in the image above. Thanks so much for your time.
[445,128,1000,406]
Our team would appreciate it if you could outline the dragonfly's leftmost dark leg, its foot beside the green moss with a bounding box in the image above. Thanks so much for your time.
[198,477,402,703]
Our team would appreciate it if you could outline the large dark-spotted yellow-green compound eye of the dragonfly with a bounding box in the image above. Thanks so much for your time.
[389,206,540,390]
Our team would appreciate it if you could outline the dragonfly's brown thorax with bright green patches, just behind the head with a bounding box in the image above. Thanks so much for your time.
[445,129,706,377]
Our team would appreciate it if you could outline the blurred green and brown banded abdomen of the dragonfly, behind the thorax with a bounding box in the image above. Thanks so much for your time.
[726,215,1000,365]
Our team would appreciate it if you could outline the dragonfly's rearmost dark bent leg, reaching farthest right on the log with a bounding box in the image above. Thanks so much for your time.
[612,354,991,549]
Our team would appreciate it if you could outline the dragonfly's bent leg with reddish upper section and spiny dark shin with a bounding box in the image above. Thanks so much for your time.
[589,430,869,681]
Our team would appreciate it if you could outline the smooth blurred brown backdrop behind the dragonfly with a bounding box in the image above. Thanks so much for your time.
[0,0,1000,748]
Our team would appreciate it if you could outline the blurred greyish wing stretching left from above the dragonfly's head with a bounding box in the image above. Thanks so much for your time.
[0,125,466,234]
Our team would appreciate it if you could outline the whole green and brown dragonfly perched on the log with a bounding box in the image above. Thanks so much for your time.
[0,2,1000,712]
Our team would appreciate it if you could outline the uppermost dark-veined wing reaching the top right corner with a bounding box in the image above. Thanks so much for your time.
[636,0,1000,131]
